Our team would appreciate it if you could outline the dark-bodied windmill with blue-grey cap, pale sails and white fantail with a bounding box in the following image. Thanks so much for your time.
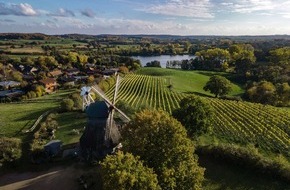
[80,75,130,160]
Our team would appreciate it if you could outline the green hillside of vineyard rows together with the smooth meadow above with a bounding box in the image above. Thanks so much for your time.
[107,69,290,158]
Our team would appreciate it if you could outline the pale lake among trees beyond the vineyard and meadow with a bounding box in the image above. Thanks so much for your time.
[132,55,195,68]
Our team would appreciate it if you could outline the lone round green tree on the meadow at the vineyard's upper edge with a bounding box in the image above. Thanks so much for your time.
[203,75,232,97]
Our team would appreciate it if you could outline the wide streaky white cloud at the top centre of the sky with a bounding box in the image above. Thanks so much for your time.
[139,0,214,18]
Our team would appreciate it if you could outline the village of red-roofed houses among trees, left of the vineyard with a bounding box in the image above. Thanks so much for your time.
[0,63,119,102]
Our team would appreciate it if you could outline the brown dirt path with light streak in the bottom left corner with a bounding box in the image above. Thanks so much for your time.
[0,164,86,190]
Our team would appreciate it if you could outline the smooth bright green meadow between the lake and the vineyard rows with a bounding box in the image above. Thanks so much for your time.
[137,67,244,96]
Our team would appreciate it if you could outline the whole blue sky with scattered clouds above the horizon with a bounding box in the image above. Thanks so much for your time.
[0,0,290,35]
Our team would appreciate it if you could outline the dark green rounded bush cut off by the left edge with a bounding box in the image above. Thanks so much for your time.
[0,137,21,165]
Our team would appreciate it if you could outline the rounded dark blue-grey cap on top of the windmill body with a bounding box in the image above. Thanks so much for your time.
[86,101,109,118]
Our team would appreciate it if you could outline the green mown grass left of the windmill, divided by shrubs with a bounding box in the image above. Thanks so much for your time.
[0,89,86,144]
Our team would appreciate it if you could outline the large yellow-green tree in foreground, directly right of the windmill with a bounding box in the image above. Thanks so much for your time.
[122,110,204,190]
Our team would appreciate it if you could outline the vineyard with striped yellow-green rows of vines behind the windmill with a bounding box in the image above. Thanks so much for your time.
[107,74,290,157]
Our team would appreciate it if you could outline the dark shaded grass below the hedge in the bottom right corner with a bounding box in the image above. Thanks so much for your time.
[198,153,290,190]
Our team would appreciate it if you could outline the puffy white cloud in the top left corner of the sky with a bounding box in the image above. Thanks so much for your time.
[0,2,37,16]
